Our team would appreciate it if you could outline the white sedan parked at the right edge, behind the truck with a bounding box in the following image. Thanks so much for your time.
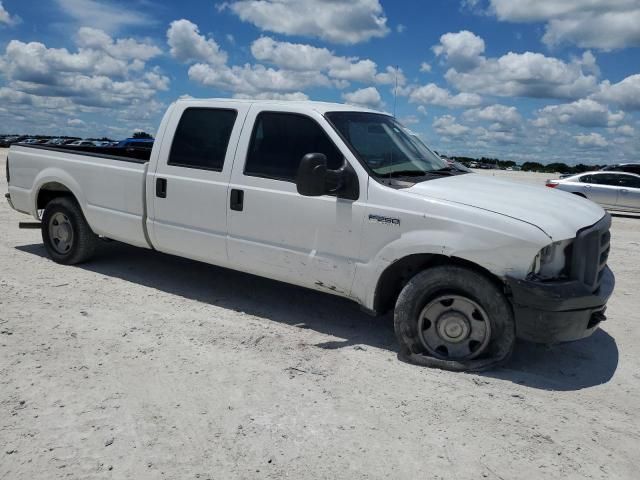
[547,170,640,212]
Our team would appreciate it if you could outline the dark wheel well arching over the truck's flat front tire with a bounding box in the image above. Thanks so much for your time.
[373,253,503,314]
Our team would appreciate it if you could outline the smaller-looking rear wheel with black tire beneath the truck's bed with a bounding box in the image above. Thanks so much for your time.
[42,197,98,265]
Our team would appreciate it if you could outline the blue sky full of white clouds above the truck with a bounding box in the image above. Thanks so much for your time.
[0,0,640,163]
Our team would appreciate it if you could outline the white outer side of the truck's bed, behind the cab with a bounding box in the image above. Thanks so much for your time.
[8,145,149,248]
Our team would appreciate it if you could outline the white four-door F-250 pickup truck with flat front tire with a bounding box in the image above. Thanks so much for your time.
[7,100,614,370]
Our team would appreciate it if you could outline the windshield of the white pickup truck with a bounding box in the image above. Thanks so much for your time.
[326,112,447,177]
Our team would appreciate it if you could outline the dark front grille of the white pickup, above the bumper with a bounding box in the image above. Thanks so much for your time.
[571,213,611,292]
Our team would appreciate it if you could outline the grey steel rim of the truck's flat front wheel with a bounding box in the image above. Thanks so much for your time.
[418,295,491,360]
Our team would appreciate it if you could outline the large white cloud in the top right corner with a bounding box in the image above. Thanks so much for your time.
[491,0,640,50]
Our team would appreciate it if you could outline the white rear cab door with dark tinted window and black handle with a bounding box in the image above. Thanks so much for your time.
[147,102,249,265]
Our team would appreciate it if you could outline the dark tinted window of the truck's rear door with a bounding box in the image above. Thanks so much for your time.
[168,108,238,172]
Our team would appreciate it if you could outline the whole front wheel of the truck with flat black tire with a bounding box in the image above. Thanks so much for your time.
[394,265,515,371]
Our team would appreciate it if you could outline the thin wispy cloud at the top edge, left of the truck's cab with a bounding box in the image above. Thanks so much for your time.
[56,0,155,33]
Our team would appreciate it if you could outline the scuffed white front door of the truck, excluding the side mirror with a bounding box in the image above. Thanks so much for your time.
[228,106,366,296]
